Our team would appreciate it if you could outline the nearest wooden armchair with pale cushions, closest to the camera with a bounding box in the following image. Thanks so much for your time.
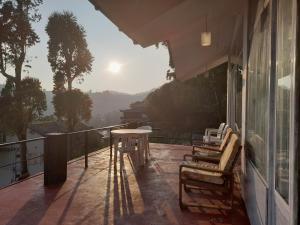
[179,134,241,209]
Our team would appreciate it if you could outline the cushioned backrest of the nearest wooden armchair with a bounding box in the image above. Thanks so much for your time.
[219,134,240,171]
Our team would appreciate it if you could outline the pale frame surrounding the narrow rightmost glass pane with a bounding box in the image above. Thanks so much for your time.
[268,0,297,225]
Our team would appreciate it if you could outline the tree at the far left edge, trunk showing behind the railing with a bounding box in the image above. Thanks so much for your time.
[0,0,45,178]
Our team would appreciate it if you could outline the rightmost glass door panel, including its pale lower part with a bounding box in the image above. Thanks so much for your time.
[274,0,295,225]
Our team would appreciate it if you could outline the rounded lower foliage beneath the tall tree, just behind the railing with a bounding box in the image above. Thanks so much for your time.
[53,89,92,130]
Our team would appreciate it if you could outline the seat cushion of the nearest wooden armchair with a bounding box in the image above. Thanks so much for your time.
[181,161,224,184]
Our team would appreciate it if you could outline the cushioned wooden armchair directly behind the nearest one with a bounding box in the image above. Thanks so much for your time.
[192,128,233,163]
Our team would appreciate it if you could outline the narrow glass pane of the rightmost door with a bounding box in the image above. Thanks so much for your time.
[275,0,294,202]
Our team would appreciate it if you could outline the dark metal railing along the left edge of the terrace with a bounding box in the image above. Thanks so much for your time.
[0,123,129,188]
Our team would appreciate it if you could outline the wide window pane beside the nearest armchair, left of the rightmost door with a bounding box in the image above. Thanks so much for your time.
[246,4,270,178]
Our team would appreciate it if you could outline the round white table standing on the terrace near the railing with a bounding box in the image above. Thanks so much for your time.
[111,129,152,165]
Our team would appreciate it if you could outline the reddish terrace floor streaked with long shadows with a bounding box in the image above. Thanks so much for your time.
[0,144,249,225]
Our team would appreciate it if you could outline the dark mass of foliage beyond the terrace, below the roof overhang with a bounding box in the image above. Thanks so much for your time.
[145,64,227,132]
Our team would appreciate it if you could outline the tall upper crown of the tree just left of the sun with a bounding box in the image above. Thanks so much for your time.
[46,12,93,91]
